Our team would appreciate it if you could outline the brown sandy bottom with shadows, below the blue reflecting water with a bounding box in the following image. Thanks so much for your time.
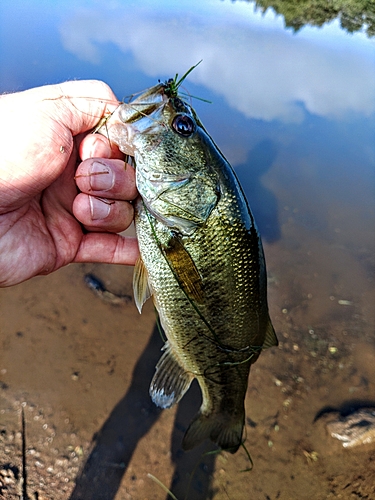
[0,207,375,500]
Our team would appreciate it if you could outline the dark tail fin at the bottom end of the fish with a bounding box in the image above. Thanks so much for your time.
[182,412,245,453]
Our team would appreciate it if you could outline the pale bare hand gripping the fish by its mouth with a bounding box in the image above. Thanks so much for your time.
[0,80,139,287]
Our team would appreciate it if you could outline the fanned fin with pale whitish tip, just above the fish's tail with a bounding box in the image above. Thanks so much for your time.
[150,342,194,408]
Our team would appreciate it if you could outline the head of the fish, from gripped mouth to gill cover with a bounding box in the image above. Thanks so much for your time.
[103,82,219,234]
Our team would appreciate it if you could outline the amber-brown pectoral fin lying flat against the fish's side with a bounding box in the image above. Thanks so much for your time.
[164,236,204,303]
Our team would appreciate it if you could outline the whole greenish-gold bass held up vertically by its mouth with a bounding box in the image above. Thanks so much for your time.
[98,70,278,453]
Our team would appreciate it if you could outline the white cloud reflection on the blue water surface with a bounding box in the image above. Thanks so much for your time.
[60,1,375,123]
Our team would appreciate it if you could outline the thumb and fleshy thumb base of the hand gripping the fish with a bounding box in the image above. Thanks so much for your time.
[0,80,118,207]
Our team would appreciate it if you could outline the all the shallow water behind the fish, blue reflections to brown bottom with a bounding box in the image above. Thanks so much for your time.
[0,0,375,500]
